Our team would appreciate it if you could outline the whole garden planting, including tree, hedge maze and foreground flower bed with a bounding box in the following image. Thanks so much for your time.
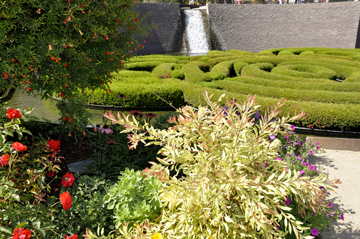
[0,0,350,239]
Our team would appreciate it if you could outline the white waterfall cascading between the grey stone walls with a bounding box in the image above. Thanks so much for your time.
[182,9,210,53]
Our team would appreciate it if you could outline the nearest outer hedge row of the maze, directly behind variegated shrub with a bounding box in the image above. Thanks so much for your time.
[169,79,360,130]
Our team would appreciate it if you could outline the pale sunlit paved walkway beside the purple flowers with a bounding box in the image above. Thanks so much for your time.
[309,148,360,239]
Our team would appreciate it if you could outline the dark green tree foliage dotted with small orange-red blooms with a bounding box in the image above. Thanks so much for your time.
[0,0,151,101]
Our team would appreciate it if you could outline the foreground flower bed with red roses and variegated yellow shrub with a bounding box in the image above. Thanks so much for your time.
[0,93,343,239]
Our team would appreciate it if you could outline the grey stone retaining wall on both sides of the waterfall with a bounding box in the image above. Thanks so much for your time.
[134,2,360,54]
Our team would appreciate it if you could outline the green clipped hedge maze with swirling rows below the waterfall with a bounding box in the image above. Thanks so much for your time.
[79,48,360,131]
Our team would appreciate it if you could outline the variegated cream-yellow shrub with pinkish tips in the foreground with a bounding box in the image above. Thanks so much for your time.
[104,92,340,238]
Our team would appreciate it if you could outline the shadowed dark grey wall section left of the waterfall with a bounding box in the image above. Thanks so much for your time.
[137,3,182,55]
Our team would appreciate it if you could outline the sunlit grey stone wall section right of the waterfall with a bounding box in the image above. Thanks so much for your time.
[208,2,360,51]
